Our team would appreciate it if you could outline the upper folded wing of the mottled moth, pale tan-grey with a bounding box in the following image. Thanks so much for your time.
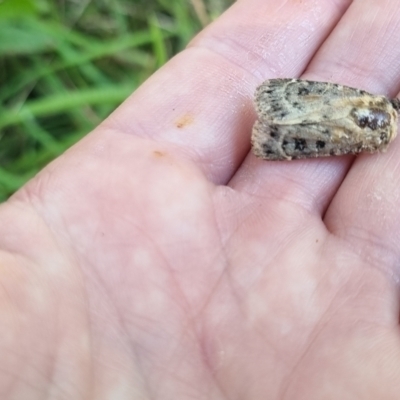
[255,79,367,125]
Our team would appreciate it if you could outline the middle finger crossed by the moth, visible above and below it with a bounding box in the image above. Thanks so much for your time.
[231,0,400,217]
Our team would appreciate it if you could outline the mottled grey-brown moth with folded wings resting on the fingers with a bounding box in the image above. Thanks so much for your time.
[251,79,400,160]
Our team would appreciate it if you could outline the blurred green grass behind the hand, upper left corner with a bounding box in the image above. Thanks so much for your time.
[0,0,234,201]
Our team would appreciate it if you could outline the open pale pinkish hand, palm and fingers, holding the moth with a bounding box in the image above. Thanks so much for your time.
[0,0,400,400]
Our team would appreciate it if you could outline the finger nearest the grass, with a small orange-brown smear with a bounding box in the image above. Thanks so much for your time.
[105,0,350,183]
